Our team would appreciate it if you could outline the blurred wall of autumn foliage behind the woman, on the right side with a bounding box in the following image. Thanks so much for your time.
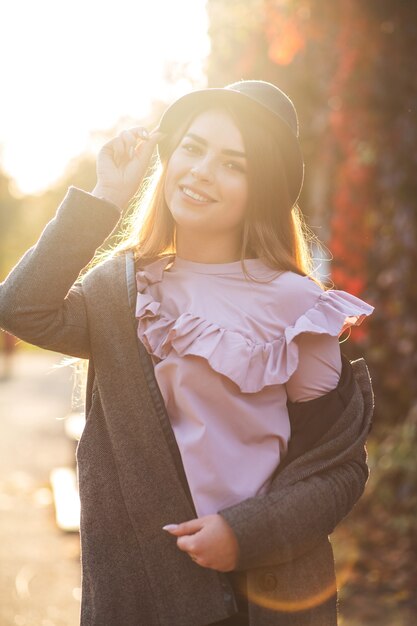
[208,0,417,626]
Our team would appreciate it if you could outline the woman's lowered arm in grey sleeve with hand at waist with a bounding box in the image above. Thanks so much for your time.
[167,357,374,571]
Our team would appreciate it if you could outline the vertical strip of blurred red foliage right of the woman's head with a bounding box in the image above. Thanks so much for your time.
[328,0,377,322]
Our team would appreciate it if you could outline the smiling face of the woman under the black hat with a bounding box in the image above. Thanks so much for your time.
[165,109,248,241]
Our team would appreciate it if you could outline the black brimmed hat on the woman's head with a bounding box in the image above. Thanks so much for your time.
[159,80,304,206]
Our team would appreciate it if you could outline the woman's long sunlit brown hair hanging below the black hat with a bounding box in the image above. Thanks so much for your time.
[88,98,325,288]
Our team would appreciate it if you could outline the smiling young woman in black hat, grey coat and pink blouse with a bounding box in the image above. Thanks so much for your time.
[0,81,373,626]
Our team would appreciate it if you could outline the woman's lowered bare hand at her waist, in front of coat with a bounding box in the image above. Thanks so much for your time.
[164,514,239,572]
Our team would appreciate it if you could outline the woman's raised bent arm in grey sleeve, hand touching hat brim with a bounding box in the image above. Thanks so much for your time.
[0,128,162,358]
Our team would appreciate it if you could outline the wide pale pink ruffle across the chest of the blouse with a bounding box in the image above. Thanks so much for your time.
[136,257,374,393]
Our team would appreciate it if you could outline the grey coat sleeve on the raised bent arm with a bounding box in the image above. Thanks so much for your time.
[0,187,120,358]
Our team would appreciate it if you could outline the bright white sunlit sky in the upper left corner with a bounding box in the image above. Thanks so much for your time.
[0,0,210,193]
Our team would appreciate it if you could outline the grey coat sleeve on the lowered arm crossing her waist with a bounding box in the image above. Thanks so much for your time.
[219,365,373,570]
